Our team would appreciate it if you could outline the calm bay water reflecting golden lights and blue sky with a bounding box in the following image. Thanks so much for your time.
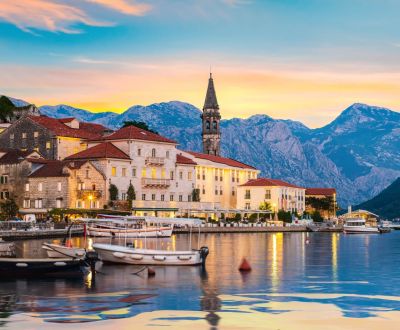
[0,232,400,329]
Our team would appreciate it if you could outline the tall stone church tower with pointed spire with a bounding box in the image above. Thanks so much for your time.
[201,73,221,156]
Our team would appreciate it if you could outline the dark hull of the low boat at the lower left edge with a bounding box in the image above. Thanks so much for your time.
[0,258,84,278]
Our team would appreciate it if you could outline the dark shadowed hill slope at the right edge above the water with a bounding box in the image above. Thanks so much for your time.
[354,178,400,219]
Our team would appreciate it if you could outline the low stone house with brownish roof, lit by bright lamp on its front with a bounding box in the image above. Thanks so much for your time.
[22,161,107,213]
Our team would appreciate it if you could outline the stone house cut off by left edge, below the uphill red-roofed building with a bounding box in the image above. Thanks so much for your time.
[0,148,46,205]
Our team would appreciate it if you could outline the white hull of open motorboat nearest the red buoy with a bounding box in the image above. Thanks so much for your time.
[93,243,208,266]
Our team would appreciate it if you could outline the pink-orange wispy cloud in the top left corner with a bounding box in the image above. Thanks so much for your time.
[0,0,112,33]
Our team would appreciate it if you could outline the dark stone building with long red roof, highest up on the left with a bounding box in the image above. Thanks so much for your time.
[0,115,108,160]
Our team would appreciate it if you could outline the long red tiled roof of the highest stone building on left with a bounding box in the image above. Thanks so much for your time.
[29,116,101,139]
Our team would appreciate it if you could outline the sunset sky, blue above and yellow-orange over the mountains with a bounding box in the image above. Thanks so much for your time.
[0,0,400,127]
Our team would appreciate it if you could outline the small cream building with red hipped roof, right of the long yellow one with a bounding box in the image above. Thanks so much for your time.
[237,178,306,214]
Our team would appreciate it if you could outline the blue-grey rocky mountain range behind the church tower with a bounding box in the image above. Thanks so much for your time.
[3,94,400,208]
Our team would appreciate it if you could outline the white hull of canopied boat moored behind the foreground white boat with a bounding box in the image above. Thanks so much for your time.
[87,227,172,238]
